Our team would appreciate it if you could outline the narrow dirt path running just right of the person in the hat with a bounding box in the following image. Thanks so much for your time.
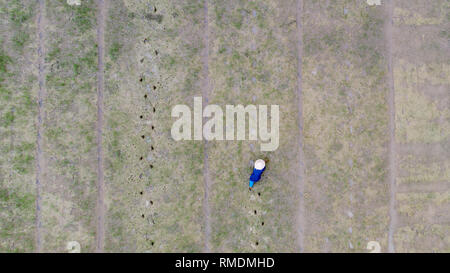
[296,0,305,252]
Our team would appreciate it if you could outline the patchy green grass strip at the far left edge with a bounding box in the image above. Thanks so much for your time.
[0,0,37,252]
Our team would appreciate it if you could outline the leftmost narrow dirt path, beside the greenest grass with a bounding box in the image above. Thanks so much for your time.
[35,0,46,252]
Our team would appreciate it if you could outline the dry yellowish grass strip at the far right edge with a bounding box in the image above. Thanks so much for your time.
[394,1,450,252]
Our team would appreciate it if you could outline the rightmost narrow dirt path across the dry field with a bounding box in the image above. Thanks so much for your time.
[384,1,397,253]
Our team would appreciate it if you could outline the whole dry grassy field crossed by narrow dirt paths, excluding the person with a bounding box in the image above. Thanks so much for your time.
[0,0,450,252]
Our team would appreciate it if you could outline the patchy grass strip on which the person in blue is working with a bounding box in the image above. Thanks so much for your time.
[208,1,298,252]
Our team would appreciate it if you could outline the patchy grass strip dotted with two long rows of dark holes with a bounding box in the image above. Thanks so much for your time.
[103,1,204,252]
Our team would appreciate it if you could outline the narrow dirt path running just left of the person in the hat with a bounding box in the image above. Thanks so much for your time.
[202,0,211,252]
